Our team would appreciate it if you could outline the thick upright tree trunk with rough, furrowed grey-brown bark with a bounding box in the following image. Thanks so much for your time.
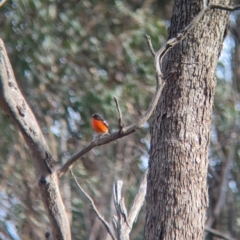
[145,0,231,240]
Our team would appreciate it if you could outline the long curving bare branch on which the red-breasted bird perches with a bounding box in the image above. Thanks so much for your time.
[58,2,238,177]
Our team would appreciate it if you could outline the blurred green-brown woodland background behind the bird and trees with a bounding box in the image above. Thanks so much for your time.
[0,0,240,240]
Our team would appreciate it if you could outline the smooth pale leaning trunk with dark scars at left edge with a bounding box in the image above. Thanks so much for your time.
[0,39,71,240]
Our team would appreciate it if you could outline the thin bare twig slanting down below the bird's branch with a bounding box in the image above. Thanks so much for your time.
[70,170,116,240]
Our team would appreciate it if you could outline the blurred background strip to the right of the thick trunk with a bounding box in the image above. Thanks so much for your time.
[206,1,240,239]
